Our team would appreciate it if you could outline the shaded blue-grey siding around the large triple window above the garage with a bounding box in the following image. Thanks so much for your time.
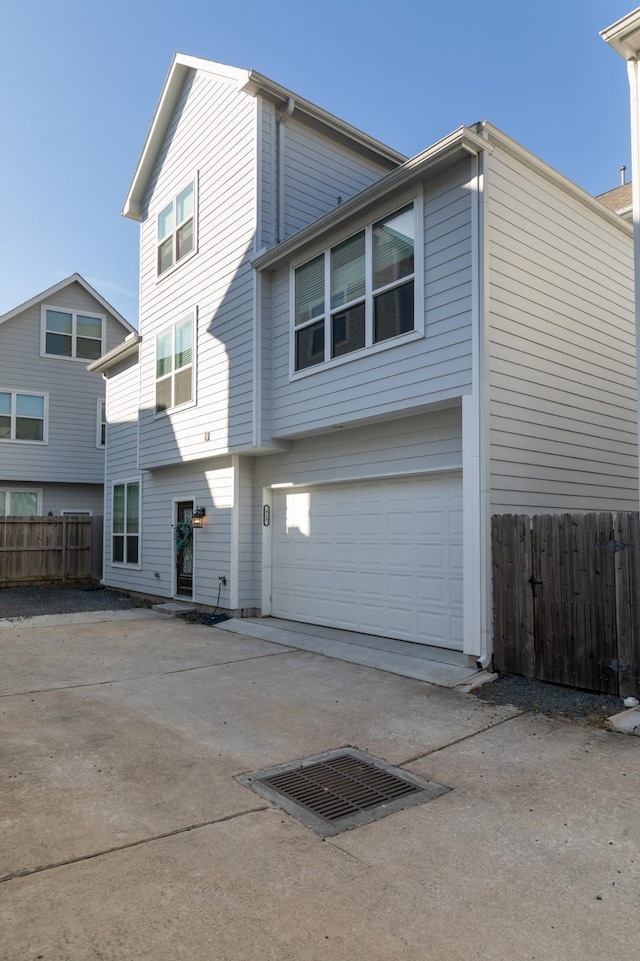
[263,163,472,438]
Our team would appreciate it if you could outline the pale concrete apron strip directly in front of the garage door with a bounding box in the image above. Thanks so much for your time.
[217,617,478,687]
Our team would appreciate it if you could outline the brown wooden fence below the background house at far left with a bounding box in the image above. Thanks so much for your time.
[0,515,102,587]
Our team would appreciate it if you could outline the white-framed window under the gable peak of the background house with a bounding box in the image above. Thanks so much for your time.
[40,305,107,363]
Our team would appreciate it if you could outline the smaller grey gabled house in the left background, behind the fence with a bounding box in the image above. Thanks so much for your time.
[0,274,133,517]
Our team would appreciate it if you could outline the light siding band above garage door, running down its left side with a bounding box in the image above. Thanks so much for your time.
[246,406,462,608]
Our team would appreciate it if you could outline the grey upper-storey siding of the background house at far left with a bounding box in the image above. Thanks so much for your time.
[0,283,126,484]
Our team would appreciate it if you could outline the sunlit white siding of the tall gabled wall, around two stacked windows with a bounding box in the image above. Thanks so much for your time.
[140,73,256,467]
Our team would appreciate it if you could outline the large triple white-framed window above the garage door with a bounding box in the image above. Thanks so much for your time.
[293,203,416,371]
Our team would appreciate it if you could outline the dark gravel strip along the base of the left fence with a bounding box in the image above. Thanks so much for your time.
[0,586,141,619]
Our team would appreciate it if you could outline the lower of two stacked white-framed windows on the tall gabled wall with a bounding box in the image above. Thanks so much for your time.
[156,314,195,414]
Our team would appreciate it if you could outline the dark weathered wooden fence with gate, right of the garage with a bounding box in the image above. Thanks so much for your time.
[492,512,640,696]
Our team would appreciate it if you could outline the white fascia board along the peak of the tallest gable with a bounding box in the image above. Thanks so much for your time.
[122,53,249,221]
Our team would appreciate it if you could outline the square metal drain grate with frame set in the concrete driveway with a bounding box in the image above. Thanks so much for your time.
[237,747,451,837]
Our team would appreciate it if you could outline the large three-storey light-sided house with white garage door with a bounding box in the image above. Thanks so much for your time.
[92,56,638,663]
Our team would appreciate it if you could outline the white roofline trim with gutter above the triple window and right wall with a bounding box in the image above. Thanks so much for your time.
[251,121,632,271]
